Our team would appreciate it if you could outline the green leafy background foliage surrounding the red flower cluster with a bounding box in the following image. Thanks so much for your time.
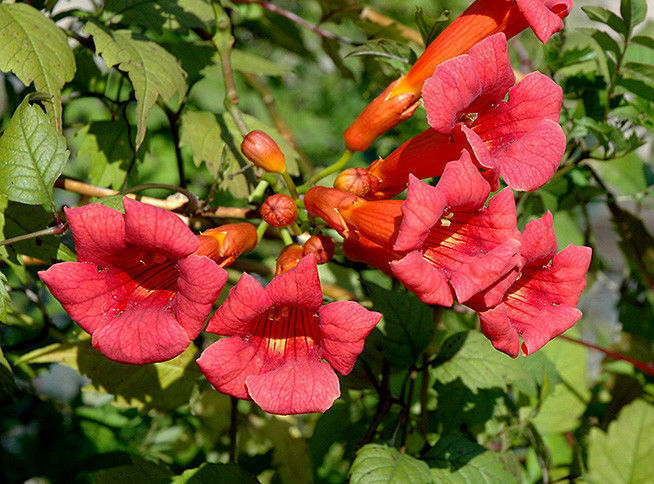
[0,0,654,484]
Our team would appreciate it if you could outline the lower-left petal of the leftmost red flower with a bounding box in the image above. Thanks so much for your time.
[39,262,115,334]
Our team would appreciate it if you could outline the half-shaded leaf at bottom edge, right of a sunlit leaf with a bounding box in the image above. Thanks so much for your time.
[427,434,520,484]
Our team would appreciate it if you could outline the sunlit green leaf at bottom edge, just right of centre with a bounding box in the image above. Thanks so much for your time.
[350,444,432,484]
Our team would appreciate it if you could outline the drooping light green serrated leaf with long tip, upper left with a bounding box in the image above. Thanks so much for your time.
[84,22,186,150]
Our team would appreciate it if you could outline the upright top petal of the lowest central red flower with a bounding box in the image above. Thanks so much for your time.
[266,254,322,312]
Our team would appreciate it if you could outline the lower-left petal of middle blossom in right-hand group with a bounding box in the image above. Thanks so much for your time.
[389,250,454,307]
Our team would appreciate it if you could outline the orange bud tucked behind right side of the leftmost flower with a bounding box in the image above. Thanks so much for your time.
[196,223,257,267]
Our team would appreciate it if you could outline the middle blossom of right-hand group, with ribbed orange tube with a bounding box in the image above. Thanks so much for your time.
[305,153,520,306]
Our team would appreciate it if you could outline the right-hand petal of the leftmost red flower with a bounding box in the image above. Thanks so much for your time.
[173,255,227,339]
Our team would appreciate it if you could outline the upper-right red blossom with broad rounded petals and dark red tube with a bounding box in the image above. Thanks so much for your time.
[366,34,566,198]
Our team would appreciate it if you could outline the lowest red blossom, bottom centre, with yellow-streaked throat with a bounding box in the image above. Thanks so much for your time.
[198,254,381,415]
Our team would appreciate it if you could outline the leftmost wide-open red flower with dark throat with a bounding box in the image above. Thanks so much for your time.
[39,198,227,364]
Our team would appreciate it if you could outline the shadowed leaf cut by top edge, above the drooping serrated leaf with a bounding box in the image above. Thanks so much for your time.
[104,0,213,32]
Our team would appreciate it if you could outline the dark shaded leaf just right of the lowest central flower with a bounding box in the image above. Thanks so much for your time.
[365,282,435,368]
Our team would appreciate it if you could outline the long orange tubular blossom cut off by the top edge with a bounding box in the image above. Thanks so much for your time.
[344,0,572,151]
